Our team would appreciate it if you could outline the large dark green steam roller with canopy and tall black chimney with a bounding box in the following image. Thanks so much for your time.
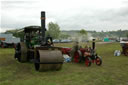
[14,11,64,71]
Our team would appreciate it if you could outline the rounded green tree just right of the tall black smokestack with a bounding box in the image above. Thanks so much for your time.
[46,22,60,39]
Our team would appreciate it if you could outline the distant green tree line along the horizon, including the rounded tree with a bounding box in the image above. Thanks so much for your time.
[5,22,128,39]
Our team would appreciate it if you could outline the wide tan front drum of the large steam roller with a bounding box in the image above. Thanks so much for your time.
[35,50,64,71]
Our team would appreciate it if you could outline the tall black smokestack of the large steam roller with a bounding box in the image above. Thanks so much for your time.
[41,11,46,43]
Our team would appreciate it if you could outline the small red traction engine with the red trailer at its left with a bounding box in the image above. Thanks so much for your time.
[62,39,102,66]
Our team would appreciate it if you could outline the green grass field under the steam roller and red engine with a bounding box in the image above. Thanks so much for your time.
[0,43,128,85]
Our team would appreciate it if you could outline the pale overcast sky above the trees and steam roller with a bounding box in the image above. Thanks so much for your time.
[0,0,128,32]
